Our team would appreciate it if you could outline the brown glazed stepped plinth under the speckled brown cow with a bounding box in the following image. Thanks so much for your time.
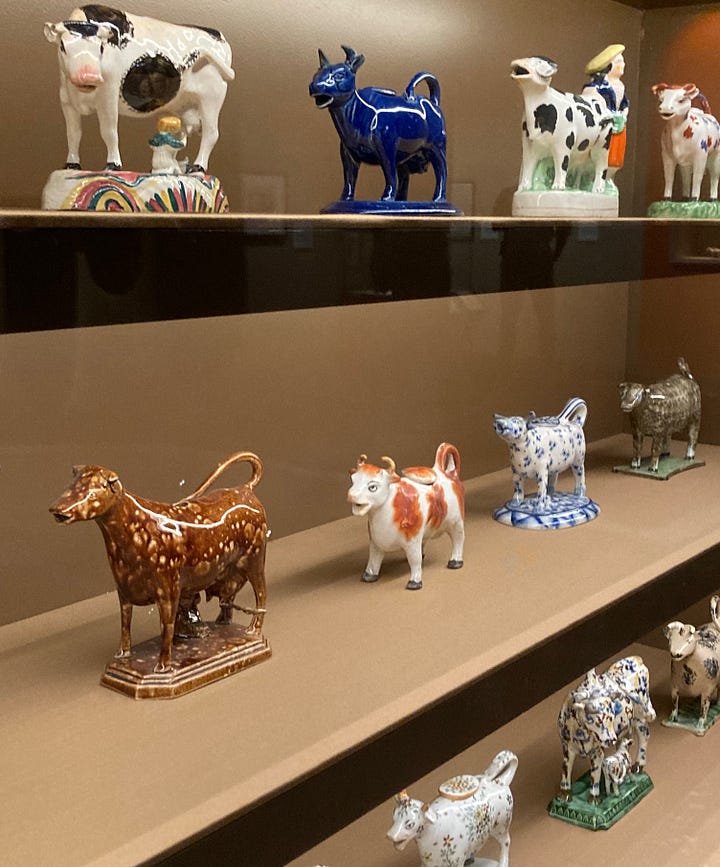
[100,623,271,698]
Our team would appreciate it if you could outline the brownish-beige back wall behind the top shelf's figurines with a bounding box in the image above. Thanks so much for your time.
[0,0,642,215]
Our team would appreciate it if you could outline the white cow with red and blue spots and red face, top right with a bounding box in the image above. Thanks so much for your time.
[652,82,720,201]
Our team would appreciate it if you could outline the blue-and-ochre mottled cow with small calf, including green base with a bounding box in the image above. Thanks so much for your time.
[548,656,655,831]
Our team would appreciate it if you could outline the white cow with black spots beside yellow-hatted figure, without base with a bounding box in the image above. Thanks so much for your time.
[511,57,613,193]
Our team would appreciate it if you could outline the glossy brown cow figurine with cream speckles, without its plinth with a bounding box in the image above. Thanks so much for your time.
[50,452,268,672]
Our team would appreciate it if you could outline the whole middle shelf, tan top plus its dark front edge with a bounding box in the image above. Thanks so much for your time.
[5,435,720,867]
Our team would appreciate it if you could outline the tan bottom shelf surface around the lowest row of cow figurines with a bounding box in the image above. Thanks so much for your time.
[290,645,720,867]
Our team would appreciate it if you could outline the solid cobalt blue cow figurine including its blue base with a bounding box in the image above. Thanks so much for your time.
[309,46,461,215]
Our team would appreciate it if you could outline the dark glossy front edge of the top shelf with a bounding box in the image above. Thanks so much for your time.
[0,211,720,332]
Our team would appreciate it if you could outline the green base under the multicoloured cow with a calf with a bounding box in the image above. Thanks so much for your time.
[548,771,653,831]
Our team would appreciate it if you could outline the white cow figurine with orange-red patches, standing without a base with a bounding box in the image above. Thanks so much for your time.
[348,443,465,590]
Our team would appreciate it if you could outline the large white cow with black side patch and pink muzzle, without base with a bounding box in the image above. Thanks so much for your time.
[45,5,235,172]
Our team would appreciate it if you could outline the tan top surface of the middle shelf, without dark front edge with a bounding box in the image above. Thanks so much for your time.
[0,436,720,867]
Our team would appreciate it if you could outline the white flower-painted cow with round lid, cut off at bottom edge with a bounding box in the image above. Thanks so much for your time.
[387,750,518,867]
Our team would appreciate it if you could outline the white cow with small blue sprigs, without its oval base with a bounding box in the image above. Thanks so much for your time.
[495,397,587,511]
